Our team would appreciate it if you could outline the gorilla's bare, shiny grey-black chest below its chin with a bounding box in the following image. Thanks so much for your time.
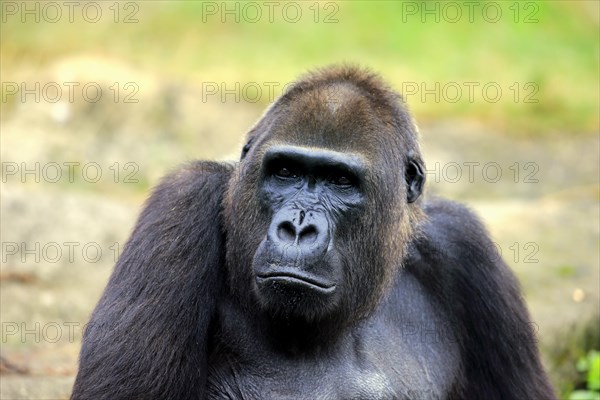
[207,277,460,400]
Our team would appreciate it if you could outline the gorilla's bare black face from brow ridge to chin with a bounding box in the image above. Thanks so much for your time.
[252,146,365,319]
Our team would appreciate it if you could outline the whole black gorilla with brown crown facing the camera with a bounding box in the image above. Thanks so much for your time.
[71,65,555,400]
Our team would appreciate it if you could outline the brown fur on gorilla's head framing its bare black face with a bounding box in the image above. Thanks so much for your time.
[224,66,424,322]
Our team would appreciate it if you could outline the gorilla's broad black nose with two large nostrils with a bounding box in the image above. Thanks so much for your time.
[269,210,329,253]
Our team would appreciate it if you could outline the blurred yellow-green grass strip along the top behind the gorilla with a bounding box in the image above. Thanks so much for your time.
[1,1,600,135]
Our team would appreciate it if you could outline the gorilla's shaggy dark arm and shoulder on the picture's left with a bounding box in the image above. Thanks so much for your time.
[72,162,230,400]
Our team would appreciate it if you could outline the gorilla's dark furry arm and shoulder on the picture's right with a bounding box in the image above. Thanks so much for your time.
[407,200,555,400]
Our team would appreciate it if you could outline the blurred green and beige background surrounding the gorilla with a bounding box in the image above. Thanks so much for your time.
[0,0,600,399]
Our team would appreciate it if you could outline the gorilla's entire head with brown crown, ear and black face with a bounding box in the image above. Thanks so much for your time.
[225,67,424,323]
